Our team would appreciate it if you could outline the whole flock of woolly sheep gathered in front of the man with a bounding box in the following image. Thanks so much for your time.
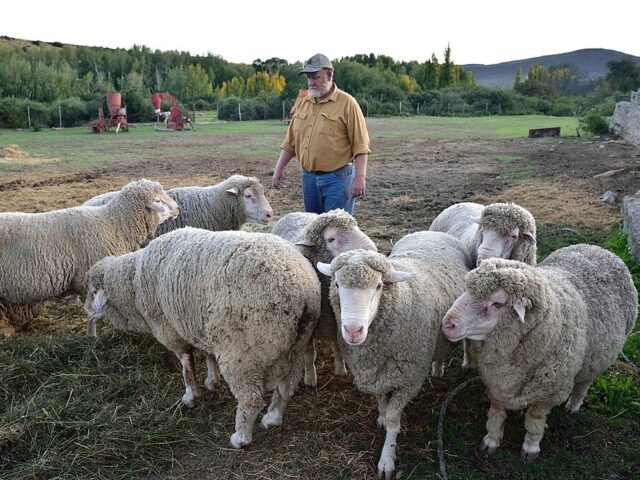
[0,175,638,479]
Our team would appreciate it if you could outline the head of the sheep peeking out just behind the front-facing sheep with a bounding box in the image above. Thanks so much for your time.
[296,209,378,261]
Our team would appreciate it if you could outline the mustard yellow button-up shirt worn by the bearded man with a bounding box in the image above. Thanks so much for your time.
[281,83,371,172]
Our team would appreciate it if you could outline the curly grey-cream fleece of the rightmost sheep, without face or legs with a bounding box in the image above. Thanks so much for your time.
[466,245,638,410]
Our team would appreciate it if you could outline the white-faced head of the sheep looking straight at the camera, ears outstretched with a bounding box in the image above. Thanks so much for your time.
[317,250,415,345]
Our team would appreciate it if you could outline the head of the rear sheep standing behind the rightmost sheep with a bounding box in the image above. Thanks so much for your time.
[477,203,536,265]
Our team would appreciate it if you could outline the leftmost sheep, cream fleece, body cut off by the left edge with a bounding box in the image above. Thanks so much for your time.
[0,180,179,306]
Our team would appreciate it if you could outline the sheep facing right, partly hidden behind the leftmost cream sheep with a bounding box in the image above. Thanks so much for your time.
[84,175,273,237]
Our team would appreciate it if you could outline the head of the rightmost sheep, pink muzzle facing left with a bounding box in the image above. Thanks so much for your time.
[442,258,540,342]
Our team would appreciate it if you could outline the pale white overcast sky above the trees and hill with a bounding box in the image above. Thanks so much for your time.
[0,0,640,65]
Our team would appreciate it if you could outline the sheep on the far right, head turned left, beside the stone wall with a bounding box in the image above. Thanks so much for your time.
[442,245,638,460]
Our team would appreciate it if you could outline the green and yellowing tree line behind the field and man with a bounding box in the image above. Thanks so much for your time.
[0,37,640,127]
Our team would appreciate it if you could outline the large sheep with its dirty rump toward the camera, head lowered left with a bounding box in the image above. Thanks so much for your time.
[86,227,320,448]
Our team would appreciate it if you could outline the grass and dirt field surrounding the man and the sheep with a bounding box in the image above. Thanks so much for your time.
[0,116,640,480]
